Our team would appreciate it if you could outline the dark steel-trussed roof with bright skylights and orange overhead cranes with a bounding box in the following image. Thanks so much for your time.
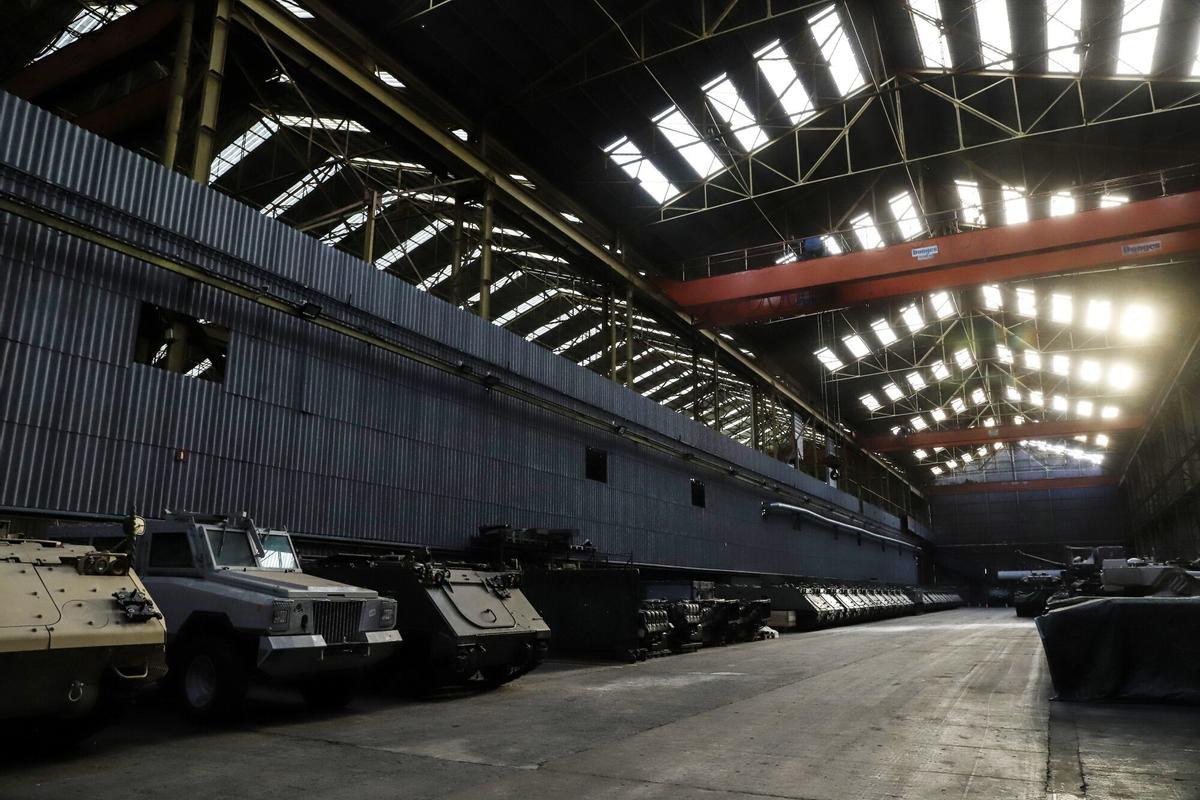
[0,0,1200,520]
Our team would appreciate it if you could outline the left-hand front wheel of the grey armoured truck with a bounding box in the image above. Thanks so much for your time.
[172,636,247,721]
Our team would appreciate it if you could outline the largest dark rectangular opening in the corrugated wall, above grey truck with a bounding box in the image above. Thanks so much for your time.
[133,302,229,384]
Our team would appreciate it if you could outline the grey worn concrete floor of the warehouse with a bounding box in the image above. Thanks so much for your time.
[0,609,1200,800]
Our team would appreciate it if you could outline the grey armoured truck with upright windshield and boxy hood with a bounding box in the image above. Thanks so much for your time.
[55,513,400,718]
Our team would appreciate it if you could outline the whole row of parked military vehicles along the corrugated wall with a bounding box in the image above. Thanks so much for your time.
[0,513,960,735]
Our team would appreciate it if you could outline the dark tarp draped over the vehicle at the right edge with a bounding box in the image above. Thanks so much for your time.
[1037,597,1200,703]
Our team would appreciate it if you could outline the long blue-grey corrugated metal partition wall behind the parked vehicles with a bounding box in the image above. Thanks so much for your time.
[0,94,916,582]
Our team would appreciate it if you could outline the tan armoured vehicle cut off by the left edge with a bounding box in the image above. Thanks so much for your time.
[0,527,167,736]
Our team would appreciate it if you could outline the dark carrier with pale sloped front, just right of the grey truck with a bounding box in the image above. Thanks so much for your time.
[306,555,550,692]
